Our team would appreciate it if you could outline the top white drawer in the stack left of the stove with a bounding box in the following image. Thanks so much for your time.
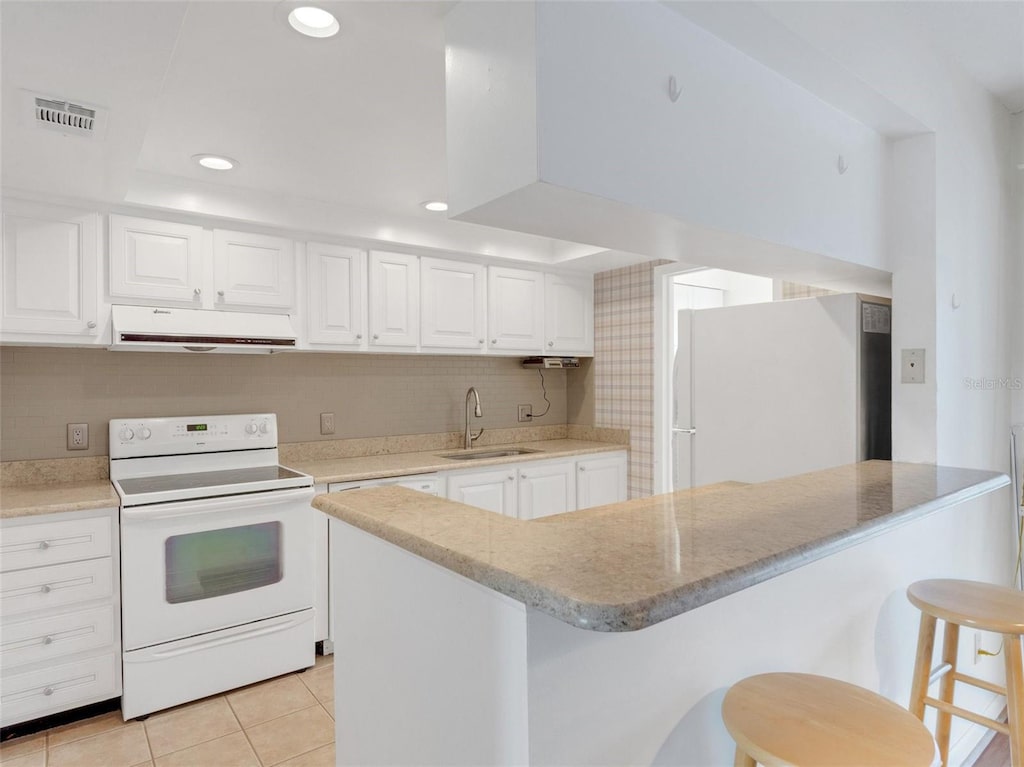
[0,516,112,571]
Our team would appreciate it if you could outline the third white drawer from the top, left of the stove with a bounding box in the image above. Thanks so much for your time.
[0,604,114,671]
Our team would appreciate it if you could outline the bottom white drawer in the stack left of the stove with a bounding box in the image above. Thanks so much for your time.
[0,652,120,726]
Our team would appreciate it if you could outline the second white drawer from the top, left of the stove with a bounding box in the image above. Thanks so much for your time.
[0,557,114,616]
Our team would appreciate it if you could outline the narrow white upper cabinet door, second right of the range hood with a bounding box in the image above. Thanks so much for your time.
[370,251,420,346]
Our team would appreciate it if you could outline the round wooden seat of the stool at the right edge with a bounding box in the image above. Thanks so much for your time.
[906,579,1024,634]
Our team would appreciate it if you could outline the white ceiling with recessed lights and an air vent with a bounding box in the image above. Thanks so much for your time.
[0,0,1024,265]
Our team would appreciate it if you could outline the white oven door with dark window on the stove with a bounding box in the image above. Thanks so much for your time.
[121,487,313,650]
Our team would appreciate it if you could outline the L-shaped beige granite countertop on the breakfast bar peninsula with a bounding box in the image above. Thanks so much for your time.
[313,461,1010,631]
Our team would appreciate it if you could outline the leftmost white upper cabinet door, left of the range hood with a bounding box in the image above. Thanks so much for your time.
[2,200,99,336]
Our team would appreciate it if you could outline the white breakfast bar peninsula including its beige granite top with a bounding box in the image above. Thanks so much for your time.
[313,461,1013,765]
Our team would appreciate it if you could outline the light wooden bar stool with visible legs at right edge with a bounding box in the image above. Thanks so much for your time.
[906,580,1024,767]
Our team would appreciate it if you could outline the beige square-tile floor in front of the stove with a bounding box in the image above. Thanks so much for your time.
[0,655,334,767]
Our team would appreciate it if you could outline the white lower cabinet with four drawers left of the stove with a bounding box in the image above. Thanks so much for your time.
[0,509,121,727]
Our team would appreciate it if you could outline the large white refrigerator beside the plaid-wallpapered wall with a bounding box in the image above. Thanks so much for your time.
[672,294,892,489]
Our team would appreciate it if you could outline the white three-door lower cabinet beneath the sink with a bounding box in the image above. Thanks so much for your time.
[446,451,627,519]
